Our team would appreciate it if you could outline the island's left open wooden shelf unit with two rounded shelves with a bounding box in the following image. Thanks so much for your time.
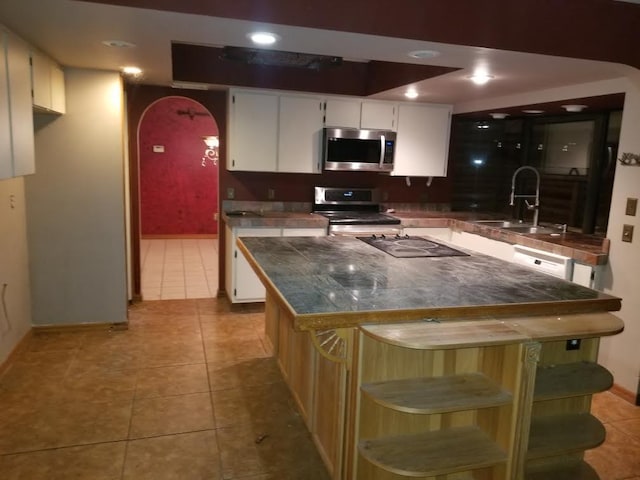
[353,323,524,480]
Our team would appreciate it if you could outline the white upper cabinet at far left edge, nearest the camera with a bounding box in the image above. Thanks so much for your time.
[0,30,35,178]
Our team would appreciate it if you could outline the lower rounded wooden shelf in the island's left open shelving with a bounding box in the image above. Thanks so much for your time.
[358,427,507,477]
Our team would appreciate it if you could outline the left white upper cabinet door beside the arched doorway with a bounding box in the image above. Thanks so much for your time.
[227,91,278,172]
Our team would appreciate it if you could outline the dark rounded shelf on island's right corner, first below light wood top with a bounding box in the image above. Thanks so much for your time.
[533,362,613,401]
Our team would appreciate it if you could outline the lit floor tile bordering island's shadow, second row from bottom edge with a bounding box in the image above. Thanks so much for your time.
[129,393,214,439]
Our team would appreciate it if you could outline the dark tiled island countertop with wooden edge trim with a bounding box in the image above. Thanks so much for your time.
[238,237,620,330]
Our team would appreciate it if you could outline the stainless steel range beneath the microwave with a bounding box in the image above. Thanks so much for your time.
[313,187,402,236]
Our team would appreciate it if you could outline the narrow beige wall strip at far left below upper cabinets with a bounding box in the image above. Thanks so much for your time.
[0,177,31,364]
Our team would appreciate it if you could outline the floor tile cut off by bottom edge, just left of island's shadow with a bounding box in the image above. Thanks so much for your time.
[123,430,222,480]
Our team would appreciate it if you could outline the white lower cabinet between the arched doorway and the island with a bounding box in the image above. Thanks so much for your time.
[226,227,280,303]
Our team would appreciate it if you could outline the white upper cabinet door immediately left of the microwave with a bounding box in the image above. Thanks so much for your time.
[278,96,323,173]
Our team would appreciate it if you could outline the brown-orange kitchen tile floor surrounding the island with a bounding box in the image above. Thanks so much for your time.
[0,298,640,480]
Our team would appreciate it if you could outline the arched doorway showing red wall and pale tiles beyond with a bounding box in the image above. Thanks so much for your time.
[138,96,219,300]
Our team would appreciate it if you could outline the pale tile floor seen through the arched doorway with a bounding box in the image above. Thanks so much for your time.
[140,239,218,300]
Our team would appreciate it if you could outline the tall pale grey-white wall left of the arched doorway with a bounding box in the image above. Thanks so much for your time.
[25,69,127,325]
